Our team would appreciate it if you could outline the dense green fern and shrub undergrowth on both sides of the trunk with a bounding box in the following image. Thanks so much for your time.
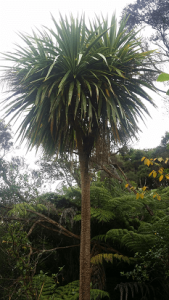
[0,135,169,300]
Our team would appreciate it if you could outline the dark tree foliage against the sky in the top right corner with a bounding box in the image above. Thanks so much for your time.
[122,0,169,89]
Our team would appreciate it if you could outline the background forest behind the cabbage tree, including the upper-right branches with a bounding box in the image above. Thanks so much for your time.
[0,0,169,300]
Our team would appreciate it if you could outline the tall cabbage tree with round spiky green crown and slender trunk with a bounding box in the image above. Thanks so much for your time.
[3,16,157,300]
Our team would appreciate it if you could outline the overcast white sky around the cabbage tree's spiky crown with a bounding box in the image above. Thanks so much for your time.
[0,0,169,164]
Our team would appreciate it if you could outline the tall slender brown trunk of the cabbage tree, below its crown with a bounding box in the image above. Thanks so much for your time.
[78,141,91,300]
